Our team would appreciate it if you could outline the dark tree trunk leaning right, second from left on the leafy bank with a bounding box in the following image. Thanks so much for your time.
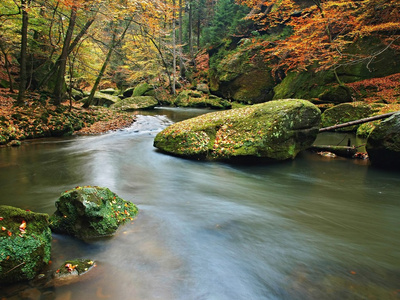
[53,6,77,105]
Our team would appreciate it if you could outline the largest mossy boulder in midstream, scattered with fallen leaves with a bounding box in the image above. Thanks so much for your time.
[154,99,321,160]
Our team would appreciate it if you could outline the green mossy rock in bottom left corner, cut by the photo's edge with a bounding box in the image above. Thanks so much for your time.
[0,205,51,284]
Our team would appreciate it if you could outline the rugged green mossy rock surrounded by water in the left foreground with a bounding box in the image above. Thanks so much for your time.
[50,186,138,239]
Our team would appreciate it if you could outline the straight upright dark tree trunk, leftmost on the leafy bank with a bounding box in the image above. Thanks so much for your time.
[16,0,29,105]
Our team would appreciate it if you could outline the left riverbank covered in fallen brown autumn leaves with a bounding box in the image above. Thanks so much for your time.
[0,89,134,145]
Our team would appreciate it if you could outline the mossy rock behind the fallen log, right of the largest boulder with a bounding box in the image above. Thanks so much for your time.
[321,102,378,132]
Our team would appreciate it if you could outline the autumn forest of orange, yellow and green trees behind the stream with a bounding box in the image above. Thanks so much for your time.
[0,0,400,137]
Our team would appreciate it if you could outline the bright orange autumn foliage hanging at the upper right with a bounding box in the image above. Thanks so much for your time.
[237,0,400,71]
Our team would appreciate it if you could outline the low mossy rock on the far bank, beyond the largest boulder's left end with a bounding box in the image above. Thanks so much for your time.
[174,90,231,109]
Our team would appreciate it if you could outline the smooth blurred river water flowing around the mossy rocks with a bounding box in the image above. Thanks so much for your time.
[0,109,400,300]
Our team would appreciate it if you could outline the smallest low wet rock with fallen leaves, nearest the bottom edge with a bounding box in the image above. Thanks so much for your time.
[53,259,96,286]
